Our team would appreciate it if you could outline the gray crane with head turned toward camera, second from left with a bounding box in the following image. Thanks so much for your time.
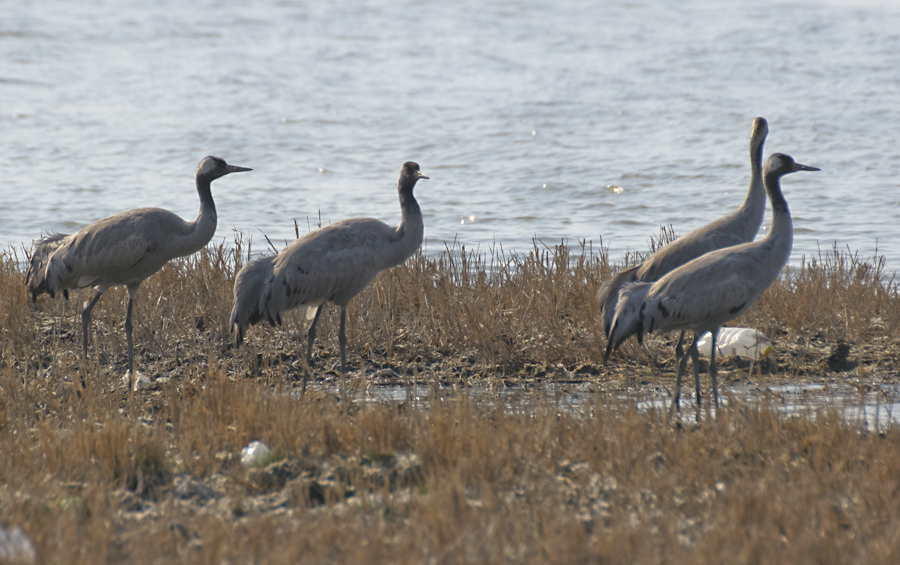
[231,161,428,387]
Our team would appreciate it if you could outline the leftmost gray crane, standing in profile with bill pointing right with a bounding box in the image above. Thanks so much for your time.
[25,157,251,382]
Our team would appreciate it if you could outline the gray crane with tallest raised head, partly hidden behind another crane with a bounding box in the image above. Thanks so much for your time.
[598,118,769,339]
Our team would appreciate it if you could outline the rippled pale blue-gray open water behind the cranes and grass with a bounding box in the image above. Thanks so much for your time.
[0,0,900,270]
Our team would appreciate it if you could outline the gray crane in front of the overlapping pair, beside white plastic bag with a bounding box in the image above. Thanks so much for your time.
[606,153,819,419]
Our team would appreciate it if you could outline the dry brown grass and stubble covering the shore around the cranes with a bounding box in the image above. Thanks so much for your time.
[0,236,900,563]
